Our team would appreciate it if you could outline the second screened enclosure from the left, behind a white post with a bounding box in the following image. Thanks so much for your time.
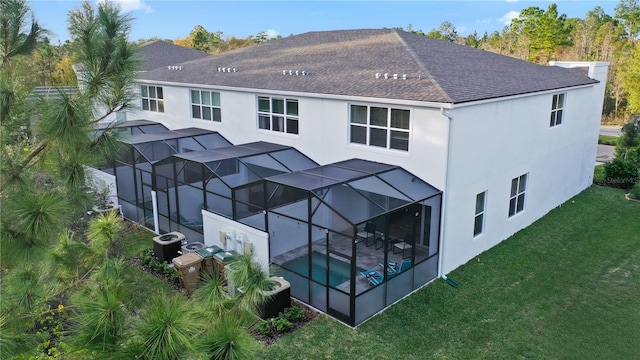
[113,128,231,229]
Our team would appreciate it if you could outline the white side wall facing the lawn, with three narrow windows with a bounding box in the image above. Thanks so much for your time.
[441,64,606,274]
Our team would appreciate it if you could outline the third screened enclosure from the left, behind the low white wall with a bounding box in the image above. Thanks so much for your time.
[153,142,318,233]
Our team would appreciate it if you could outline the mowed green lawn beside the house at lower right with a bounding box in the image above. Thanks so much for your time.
[261,186,640,360]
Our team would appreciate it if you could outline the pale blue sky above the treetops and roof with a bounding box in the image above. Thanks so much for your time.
[27,0,619,43]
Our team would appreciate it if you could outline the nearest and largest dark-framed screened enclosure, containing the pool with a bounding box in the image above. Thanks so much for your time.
[254,159,442,325]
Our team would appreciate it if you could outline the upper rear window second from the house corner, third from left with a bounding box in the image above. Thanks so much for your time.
[258,96,299,134]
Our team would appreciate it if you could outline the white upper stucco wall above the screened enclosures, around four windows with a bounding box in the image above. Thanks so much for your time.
[128,83,448,188]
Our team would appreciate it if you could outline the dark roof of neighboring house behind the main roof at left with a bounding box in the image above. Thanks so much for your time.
[140,40,210,71]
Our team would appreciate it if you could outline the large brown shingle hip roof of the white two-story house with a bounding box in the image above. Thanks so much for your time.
[140,29,597,103]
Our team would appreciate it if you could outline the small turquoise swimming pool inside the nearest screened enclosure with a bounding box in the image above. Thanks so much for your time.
[280,251,360,287]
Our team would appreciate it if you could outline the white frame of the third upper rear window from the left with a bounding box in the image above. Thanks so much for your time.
[256,95,300,135]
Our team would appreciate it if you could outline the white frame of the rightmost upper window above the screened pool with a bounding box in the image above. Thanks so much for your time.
[349,103,412,151]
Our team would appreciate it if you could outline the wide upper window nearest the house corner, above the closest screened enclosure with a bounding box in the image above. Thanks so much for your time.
[350,105,411,151]
